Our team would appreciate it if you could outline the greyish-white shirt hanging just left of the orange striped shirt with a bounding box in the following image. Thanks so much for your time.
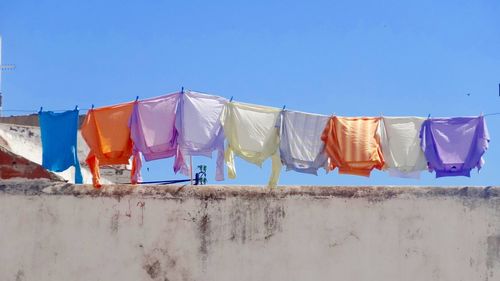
[280,110,330,175]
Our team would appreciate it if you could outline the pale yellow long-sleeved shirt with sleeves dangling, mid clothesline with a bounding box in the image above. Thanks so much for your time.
[221,102,281,187]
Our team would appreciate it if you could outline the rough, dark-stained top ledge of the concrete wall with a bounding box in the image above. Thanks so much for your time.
[0,179,500,202]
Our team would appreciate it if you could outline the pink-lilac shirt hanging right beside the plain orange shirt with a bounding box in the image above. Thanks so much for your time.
[130,93,188,175]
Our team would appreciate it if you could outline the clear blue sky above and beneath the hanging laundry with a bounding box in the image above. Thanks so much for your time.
[0,0,500,185]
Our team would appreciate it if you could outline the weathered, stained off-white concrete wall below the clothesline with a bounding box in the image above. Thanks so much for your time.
[0,178,500,281]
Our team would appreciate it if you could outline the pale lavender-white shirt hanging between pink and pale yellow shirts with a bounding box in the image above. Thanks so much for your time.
[176,91,227,181]
